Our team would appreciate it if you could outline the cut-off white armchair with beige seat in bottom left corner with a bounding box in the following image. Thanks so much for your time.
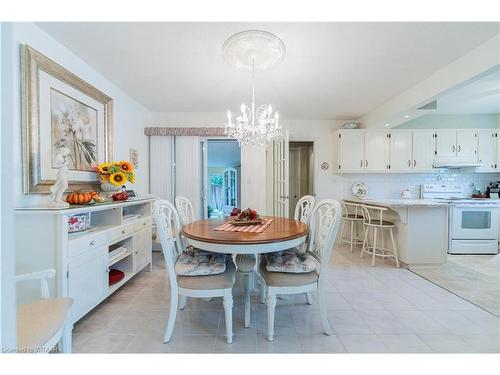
[16,269,73,353]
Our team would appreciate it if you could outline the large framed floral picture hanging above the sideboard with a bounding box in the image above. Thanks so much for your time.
[21,45,113,194]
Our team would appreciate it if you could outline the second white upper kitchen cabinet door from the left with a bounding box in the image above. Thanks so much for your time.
[365,130,391,172]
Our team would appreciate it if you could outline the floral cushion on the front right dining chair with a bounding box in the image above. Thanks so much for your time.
[266,249,319,273]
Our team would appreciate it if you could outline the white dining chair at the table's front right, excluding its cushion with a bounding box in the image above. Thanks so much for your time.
[260,199,342,341]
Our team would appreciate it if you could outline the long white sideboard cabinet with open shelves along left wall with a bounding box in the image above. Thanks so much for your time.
[15,196,154,323]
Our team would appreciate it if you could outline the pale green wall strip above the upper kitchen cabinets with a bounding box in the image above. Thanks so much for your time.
[397,114,500,129]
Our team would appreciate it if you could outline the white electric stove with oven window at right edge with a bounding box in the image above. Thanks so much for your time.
[420,184,500,254]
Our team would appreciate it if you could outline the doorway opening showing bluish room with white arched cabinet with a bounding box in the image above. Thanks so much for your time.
[203,139,241,218]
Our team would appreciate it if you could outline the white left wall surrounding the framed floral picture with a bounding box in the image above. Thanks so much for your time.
[3,23,150,206]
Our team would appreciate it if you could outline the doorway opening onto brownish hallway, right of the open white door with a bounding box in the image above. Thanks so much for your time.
[288,142,314,218]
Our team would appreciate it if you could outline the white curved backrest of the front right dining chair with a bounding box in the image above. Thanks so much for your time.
[307,199,342,281]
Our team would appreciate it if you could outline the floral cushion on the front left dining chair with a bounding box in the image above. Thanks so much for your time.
[175,246,226,276]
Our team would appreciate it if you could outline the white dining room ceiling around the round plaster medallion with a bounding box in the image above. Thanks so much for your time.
[38,22,499,119]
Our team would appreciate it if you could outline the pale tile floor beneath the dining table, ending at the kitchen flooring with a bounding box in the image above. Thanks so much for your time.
[73,248,500,353]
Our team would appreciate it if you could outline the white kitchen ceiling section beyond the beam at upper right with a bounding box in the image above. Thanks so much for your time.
[429,67,500,115]
